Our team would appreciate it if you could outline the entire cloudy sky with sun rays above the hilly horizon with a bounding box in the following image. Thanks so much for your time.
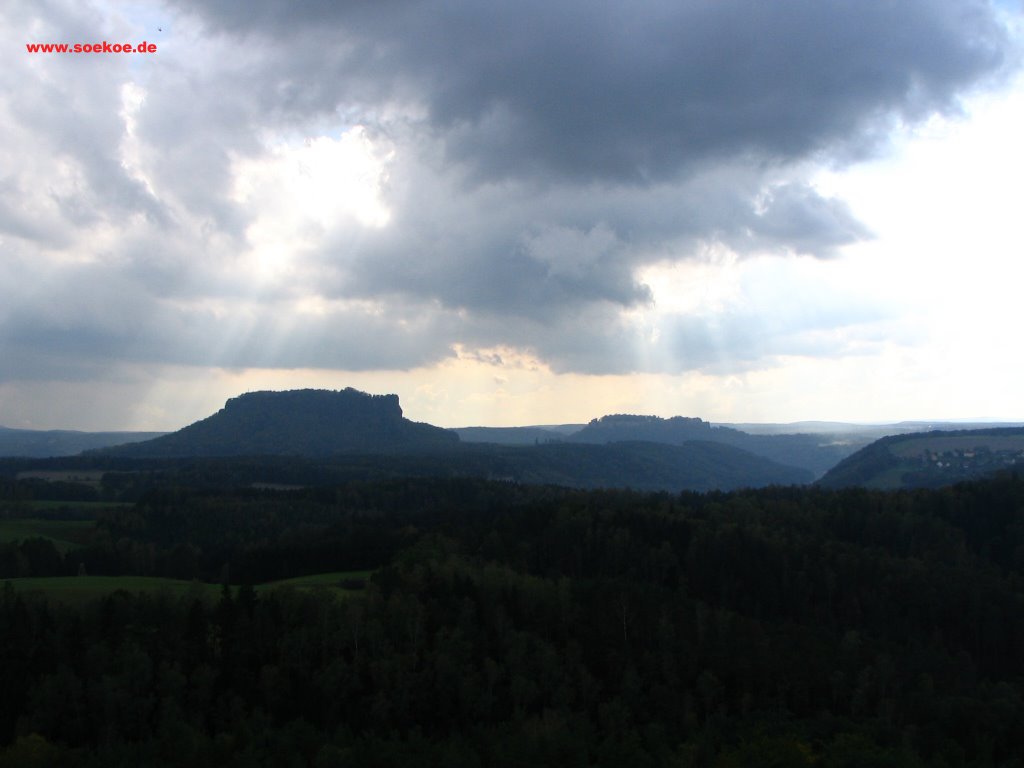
[0,0,1024,430]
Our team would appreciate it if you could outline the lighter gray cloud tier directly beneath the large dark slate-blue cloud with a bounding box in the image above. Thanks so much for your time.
[317,160,868,323]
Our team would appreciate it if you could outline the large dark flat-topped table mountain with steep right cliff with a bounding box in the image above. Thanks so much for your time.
[92,388,459,458]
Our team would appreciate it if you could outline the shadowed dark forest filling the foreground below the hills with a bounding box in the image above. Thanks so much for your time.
[0,475,1024,768]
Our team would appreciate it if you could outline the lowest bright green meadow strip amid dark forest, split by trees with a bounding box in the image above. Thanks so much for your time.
[5,570,373,604]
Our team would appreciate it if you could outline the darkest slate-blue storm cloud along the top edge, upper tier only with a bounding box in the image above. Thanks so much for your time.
[167,0,1007,183]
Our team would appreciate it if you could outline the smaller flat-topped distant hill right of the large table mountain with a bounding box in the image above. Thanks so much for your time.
[565,414,867,477]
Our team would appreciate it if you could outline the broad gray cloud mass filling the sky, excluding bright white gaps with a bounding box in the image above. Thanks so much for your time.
[0,0,1017,397]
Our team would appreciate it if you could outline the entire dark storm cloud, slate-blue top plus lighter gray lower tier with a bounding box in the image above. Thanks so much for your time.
[165,0,1011,346]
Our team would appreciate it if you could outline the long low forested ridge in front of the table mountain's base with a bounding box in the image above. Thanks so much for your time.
[9,442,813,499]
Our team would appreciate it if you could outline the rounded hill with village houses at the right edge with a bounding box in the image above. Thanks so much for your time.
[818,427,1024,488]
